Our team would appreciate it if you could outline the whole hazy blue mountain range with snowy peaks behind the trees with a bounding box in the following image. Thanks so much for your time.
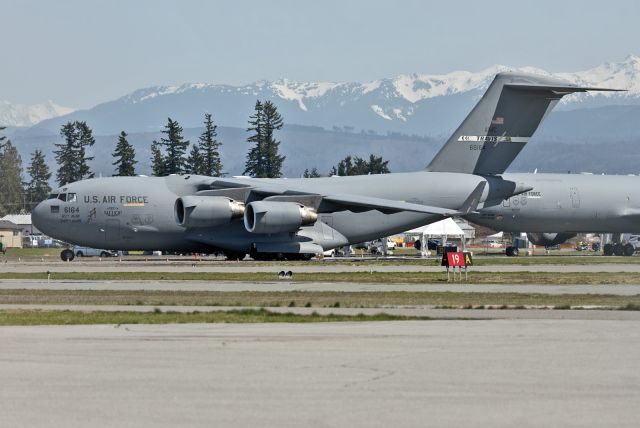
[0,55,640,177]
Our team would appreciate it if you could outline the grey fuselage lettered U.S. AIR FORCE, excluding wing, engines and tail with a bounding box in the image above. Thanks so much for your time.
[33,172,485,251]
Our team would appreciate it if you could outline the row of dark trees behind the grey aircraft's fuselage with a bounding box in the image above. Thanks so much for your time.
[0,100,390,215]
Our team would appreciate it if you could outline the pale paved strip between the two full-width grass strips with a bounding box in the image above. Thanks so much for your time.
[0,279,640,296]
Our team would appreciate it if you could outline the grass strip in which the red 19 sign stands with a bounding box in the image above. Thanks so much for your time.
[0,268,640,285]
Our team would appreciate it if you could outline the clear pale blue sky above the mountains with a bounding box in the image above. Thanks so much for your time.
[0,0,640,108]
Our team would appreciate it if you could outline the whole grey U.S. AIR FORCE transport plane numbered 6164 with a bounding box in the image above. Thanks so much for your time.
[32,73,607,260]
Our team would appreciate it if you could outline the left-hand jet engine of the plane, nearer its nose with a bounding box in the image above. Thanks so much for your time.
[175,196,245,228]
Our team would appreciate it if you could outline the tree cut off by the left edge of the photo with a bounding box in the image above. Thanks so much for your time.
[0,140,24,216]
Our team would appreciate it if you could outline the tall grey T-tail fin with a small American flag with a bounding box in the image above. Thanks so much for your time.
[427,73,615,175]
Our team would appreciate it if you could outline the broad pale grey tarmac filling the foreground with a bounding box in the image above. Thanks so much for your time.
[0,320,640,427]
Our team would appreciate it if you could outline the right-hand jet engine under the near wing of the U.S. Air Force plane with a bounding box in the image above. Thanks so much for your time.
[244,201,318,234]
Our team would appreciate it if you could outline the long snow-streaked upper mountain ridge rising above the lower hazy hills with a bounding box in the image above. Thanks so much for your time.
[32,55,640,135]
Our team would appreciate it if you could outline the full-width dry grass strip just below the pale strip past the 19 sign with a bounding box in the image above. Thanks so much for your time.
[0,287,640,309]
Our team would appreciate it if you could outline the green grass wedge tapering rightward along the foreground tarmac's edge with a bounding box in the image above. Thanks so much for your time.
[0,309,429,326]
